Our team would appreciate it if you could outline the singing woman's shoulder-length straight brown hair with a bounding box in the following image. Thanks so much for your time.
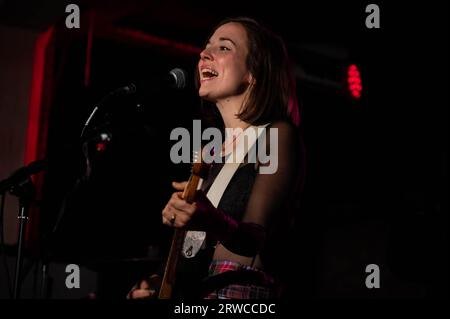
[196,17,299,125]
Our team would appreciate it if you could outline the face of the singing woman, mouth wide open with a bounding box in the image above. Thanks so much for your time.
[198,22,252,103]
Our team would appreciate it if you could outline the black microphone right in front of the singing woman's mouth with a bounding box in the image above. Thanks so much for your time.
[119,68,187,94]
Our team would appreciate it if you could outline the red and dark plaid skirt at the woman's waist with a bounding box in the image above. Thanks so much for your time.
[205,260,280,299]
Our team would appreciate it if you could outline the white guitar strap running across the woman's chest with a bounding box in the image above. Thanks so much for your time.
[181,123,270,258]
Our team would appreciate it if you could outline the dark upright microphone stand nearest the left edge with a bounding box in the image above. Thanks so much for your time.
[10,177,36,299]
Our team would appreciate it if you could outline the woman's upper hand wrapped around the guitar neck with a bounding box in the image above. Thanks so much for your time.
[162,182,197,228]
